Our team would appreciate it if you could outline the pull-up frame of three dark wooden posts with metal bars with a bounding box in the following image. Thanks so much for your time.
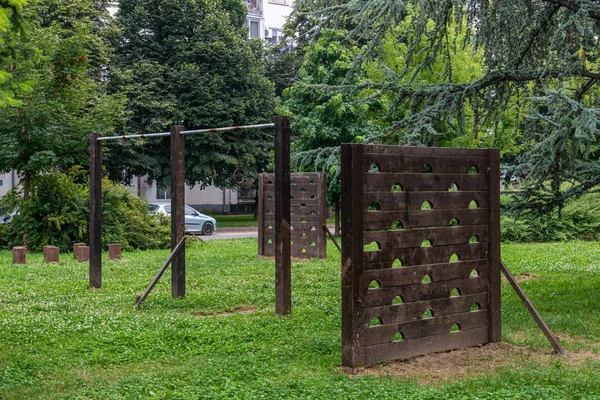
[90,116,292,315]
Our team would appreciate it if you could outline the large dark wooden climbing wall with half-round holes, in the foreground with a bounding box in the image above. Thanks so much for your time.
[342,145,501,367]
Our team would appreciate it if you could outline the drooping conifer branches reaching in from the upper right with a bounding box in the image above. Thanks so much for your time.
[298,0,600,217]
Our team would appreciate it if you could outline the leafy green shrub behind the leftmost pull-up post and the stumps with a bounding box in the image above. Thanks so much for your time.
[0,169,170,251]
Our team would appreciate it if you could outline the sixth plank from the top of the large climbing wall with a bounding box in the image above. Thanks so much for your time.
[363,242,488,269]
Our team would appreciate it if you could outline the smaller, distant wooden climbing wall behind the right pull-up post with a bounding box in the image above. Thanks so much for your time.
[258,172,327,258]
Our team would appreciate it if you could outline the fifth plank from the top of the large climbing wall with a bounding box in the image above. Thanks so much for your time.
[363,225,488,248]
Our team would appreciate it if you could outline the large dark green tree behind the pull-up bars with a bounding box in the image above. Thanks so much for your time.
[106,0,275,187]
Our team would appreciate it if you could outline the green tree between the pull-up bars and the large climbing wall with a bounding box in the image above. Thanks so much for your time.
[282,30,381,228]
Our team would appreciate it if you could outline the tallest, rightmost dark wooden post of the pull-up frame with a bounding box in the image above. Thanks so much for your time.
[275,116,292,316]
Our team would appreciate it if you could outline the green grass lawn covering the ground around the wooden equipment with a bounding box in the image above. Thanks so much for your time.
[0,239,600,399]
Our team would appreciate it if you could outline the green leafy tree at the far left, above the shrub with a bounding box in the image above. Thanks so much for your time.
[0,1,123,245]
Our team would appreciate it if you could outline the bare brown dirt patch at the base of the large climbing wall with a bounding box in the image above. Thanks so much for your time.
[357,343,600,385]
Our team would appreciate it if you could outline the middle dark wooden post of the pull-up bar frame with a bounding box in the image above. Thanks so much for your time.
[171,125,185,298]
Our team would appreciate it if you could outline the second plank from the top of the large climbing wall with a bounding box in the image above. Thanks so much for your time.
[363,172,488,192]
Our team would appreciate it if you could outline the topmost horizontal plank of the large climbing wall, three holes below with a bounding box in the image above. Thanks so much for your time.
[363,153,490,174]
